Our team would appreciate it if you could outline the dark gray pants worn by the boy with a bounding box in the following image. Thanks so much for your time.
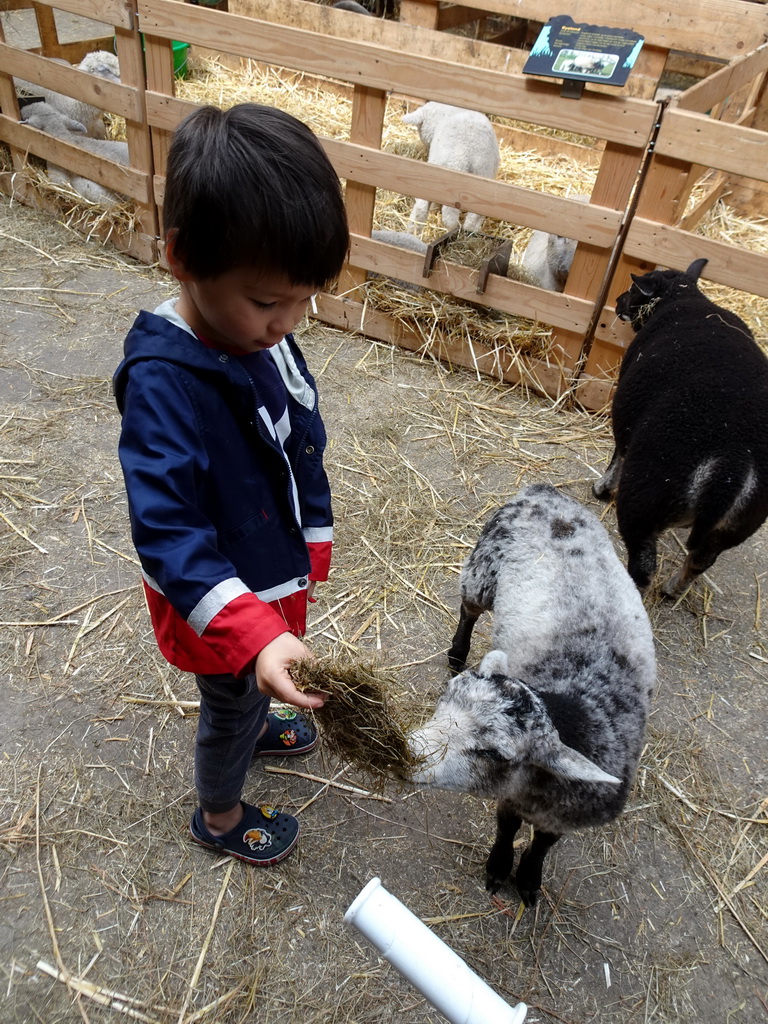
[195,673,269,814]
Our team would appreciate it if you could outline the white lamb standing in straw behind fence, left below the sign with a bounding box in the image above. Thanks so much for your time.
[402,101,500,233]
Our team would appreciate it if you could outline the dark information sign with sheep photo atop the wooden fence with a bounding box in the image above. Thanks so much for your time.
[523,14,644,86]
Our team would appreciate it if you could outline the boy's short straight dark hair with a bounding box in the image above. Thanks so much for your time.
[163,103,349,288]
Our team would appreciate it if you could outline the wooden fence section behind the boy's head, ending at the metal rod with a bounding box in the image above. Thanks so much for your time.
[138,0,656,393]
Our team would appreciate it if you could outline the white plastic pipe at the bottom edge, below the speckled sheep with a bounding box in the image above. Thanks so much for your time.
[344,879,528,1024]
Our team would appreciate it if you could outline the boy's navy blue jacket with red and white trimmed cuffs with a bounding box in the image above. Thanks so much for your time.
[114,311,333,675]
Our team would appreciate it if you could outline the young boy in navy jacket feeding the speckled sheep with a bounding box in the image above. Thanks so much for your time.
[115,103,349,864]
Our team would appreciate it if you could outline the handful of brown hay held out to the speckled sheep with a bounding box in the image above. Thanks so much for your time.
[289,658,418,781]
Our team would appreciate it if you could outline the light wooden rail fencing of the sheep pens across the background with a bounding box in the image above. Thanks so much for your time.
[0,0,768,409]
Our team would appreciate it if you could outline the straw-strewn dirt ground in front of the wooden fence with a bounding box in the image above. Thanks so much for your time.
[0,200,768,1024]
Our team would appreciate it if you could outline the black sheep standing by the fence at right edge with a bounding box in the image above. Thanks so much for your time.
[593,259,768,595]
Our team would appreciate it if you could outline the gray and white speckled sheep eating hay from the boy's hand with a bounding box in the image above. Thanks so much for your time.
[411,484,655,905]
